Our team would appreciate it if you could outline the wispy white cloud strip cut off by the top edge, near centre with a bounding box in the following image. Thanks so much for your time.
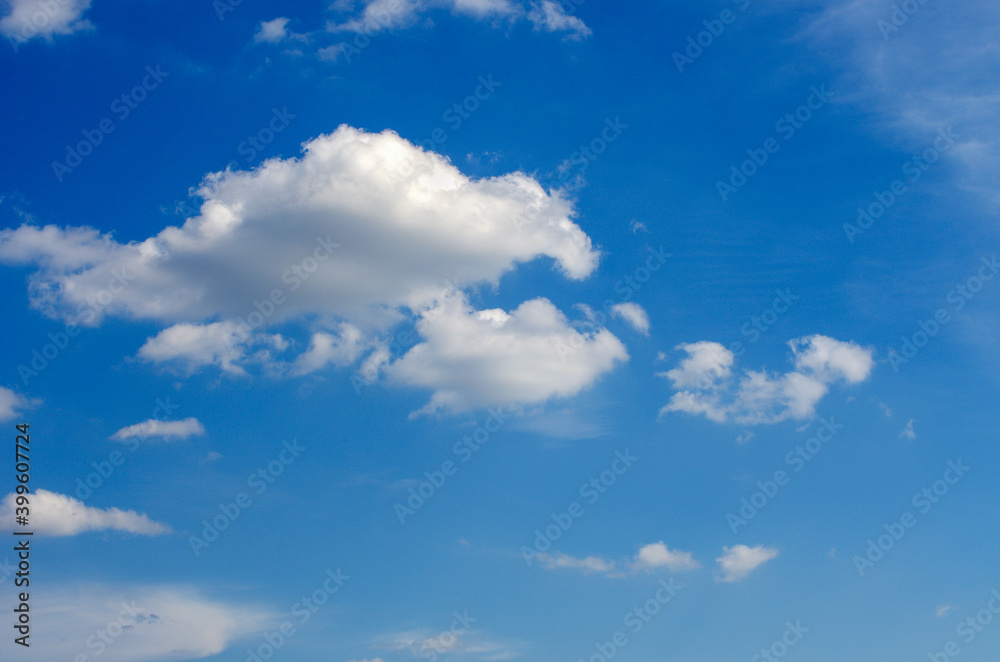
[327,0,591,41]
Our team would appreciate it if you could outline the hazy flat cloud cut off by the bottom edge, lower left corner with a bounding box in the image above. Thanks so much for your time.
[16,584,275,662]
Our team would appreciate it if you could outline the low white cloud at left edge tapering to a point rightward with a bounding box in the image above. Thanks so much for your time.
[0,490,171,536]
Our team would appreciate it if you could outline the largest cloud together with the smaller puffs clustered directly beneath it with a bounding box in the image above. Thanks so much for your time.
[0,126,624,411]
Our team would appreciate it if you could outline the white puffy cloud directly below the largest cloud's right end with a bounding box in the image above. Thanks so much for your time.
[386,295,628,413]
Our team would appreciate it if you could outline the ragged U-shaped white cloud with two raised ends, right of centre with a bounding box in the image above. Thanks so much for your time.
[660,335,874,425]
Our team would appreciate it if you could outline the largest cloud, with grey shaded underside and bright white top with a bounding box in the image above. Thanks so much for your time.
[0,126,598,330]
